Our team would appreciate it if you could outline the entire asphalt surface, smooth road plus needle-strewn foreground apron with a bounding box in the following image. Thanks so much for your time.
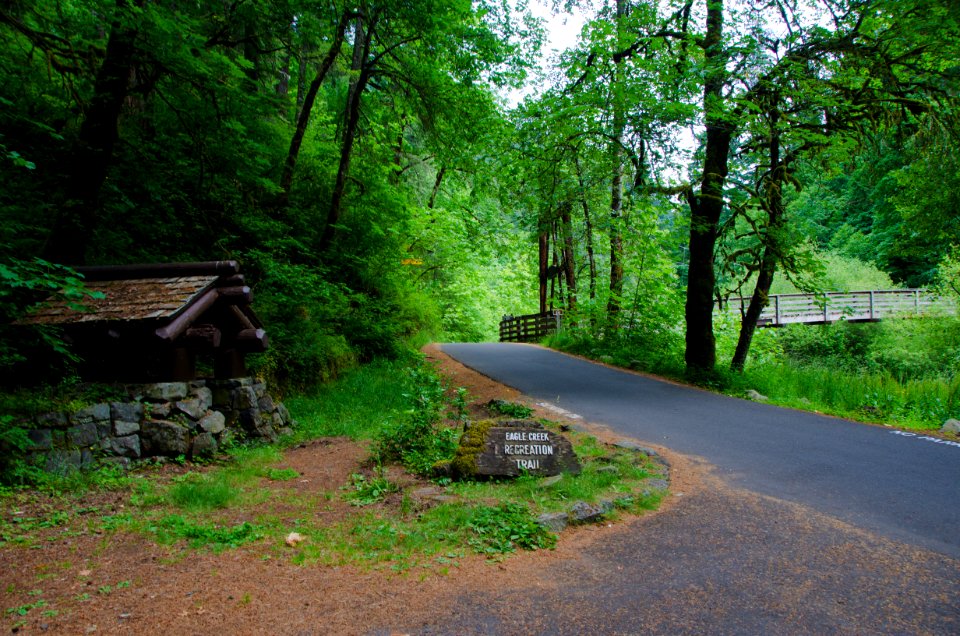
[378,344,960,634]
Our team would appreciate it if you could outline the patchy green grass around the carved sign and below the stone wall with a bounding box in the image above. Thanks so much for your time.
[0,352,662,574]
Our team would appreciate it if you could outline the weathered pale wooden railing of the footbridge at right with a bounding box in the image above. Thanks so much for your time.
[724,289,957,327]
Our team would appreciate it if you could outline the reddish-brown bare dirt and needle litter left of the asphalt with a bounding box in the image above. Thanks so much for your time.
[0,347,682,634]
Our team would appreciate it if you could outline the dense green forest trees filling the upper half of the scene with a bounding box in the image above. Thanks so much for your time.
[0,0,960,387]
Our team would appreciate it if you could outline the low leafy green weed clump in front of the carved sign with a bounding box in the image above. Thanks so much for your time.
[468,503,557,554]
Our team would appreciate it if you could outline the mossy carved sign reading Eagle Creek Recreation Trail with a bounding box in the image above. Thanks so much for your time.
[453,420,580,477]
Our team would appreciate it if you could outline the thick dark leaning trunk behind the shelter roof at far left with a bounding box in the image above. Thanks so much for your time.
[44,0,144,265]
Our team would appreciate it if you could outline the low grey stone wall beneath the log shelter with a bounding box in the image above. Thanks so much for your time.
[22,378,293,472]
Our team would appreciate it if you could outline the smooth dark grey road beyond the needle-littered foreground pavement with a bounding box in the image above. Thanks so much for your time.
[442,344,960,558]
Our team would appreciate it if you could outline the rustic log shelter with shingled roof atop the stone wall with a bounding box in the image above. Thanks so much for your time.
[21,261,269,382]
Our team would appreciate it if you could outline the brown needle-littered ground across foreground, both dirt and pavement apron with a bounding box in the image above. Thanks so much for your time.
[7,350,948,635]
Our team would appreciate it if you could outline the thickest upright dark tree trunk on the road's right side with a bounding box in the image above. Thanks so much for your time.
[684,0,733,376]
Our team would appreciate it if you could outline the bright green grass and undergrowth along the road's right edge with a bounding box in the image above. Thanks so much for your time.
[546,316,960,431]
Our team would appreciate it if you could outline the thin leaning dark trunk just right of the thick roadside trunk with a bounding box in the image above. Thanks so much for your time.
[730,108,786,371]
